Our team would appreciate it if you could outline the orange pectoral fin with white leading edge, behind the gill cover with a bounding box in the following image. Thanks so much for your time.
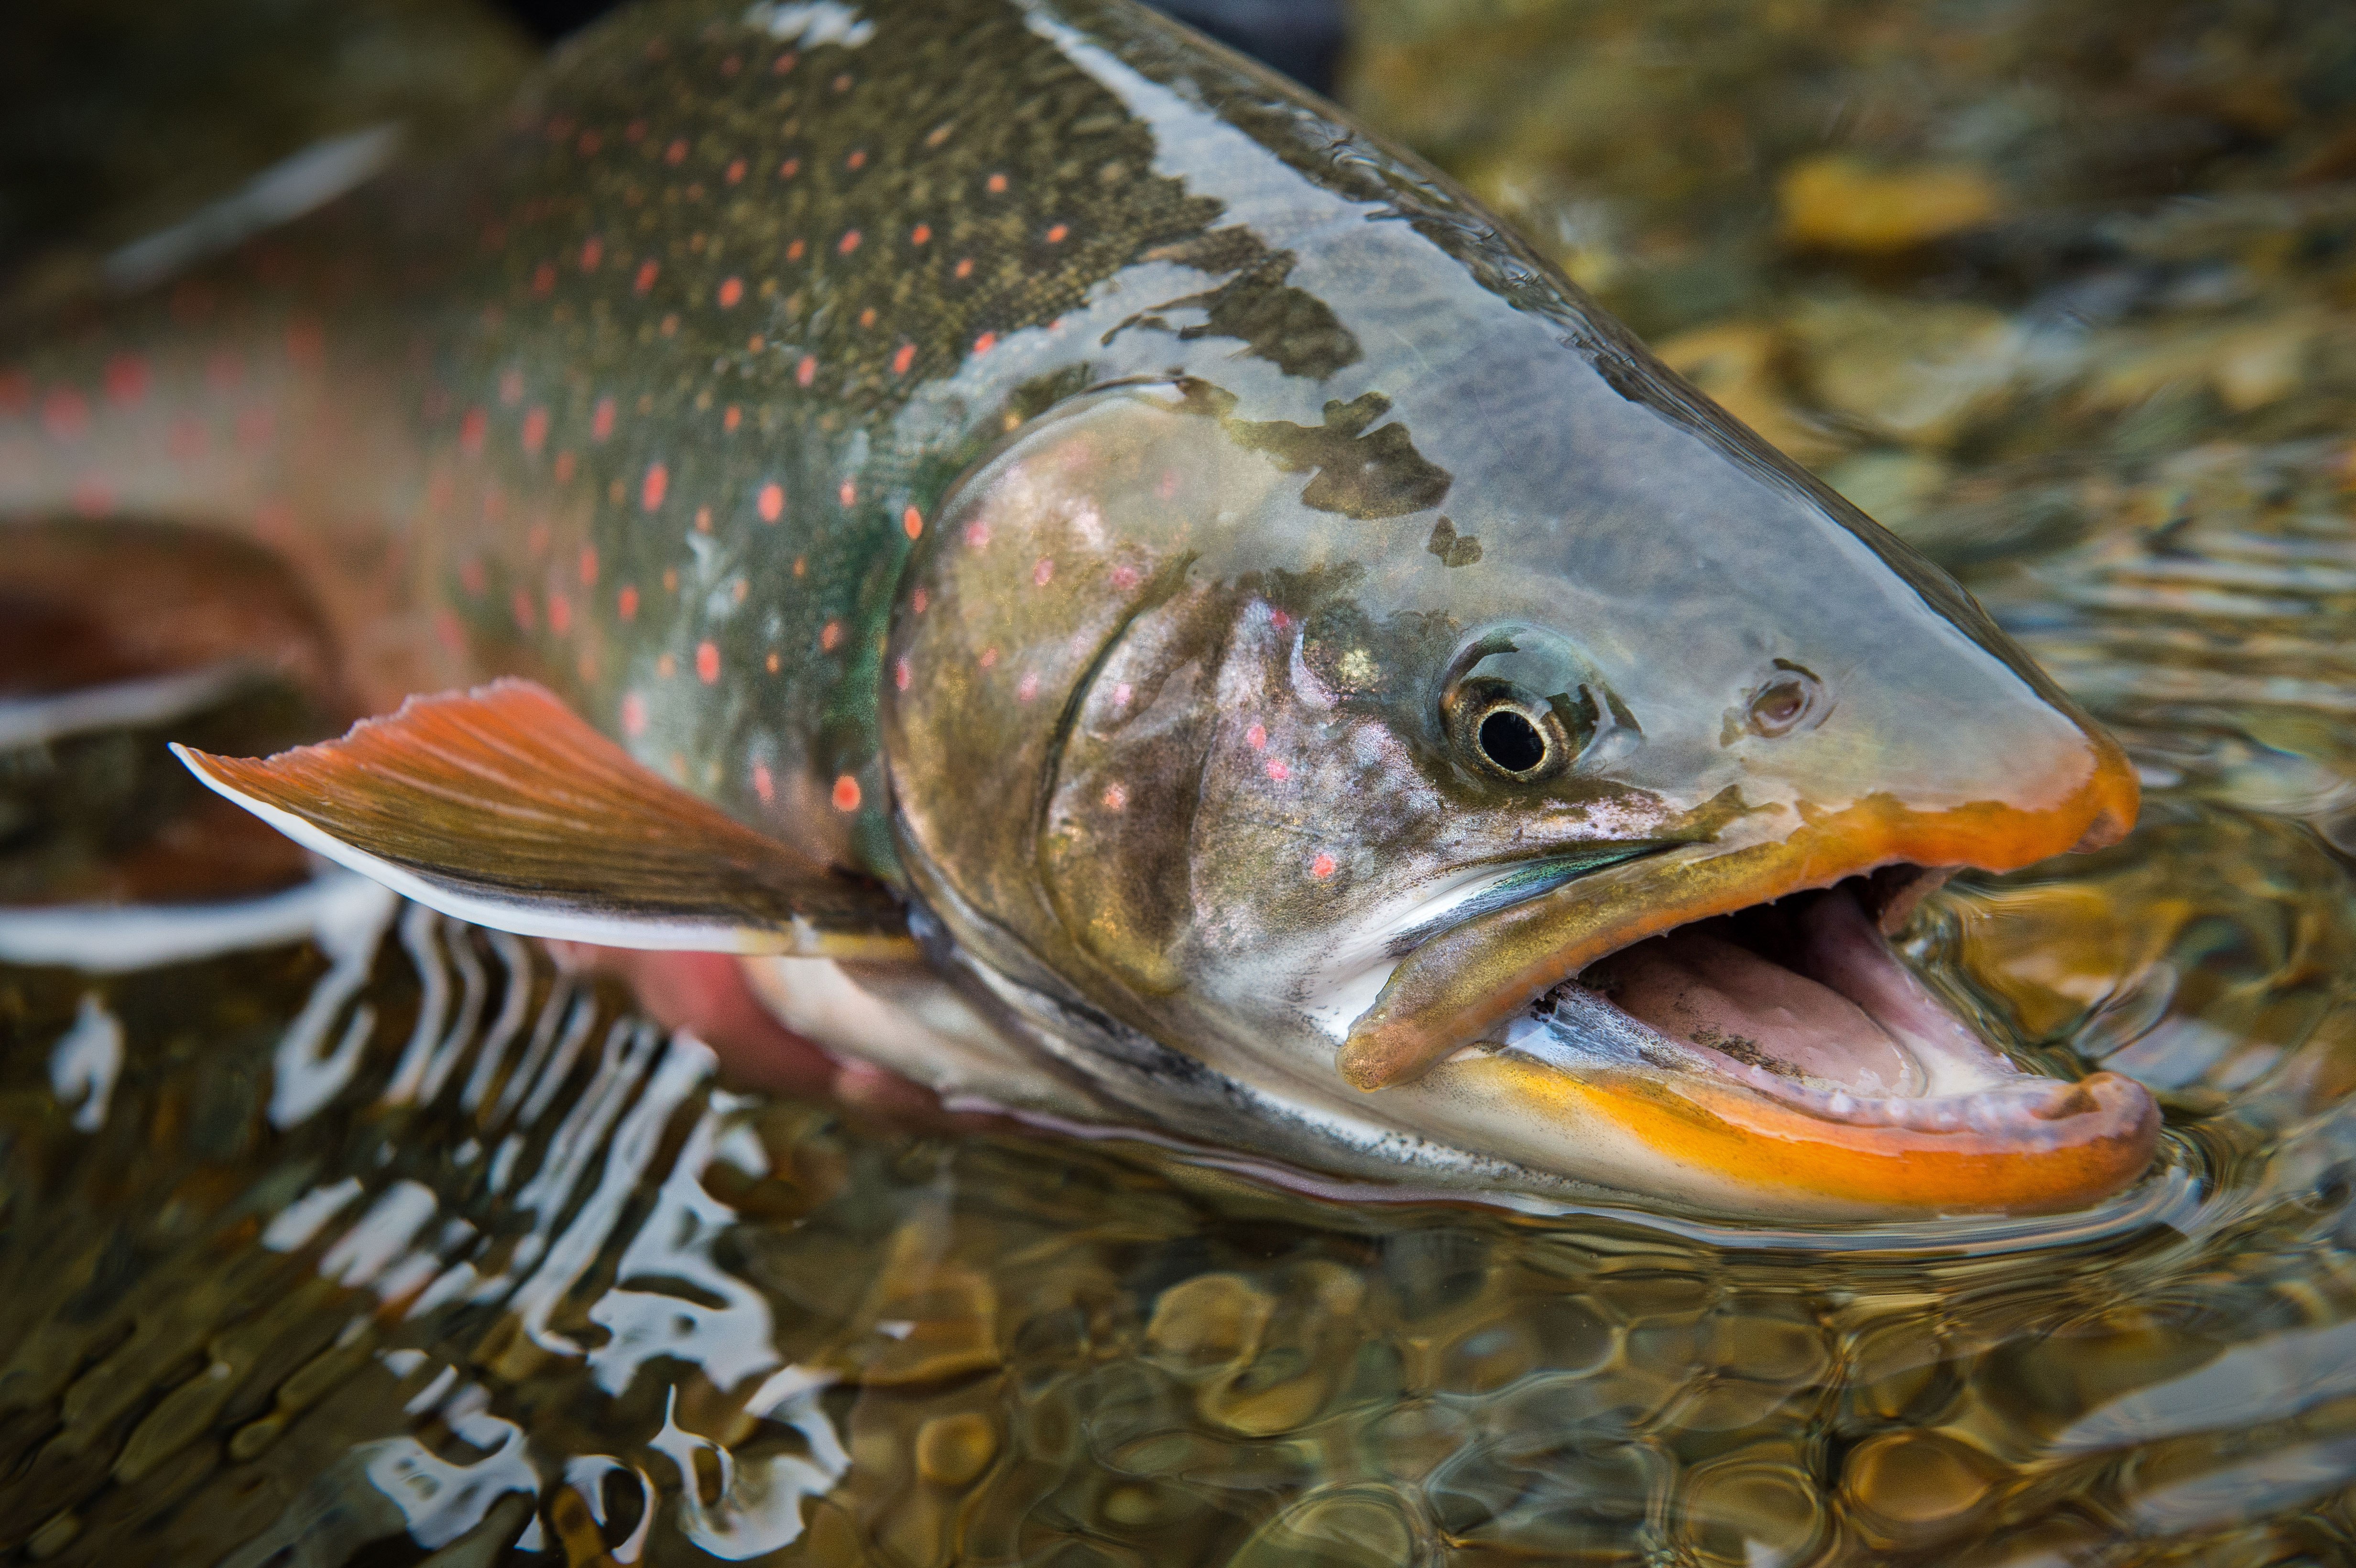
[172,680,914,958]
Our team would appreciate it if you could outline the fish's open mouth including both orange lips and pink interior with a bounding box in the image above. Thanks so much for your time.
[1338,758,2160,1212]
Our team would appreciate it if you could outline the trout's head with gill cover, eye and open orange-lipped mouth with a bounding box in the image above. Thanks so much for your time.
[884,381,2158,1217]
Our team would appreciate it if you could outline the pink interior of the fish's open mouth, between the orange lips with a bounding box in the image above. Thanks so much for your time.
[1581,878,2026,1102]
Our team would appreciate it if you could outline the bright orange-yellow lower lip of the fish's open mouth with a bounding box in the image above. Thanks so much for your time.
[1479,1057,2160,1215]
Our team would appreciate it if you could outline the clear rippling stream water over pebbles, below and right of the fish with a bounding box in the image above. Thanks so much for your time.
[13,0,2356,1568]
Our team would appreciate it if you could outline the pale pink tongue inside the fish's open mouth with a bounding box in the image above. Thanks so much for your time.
[1592,894,1925,1097]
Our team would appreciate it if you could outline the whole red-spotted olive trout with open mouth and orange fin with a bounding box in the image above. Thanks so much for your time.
[0,0,2158,1222]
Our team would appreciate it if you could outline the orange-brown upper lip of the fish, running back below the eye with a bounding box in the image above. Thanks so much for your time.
[1336,735,2139,1090]
